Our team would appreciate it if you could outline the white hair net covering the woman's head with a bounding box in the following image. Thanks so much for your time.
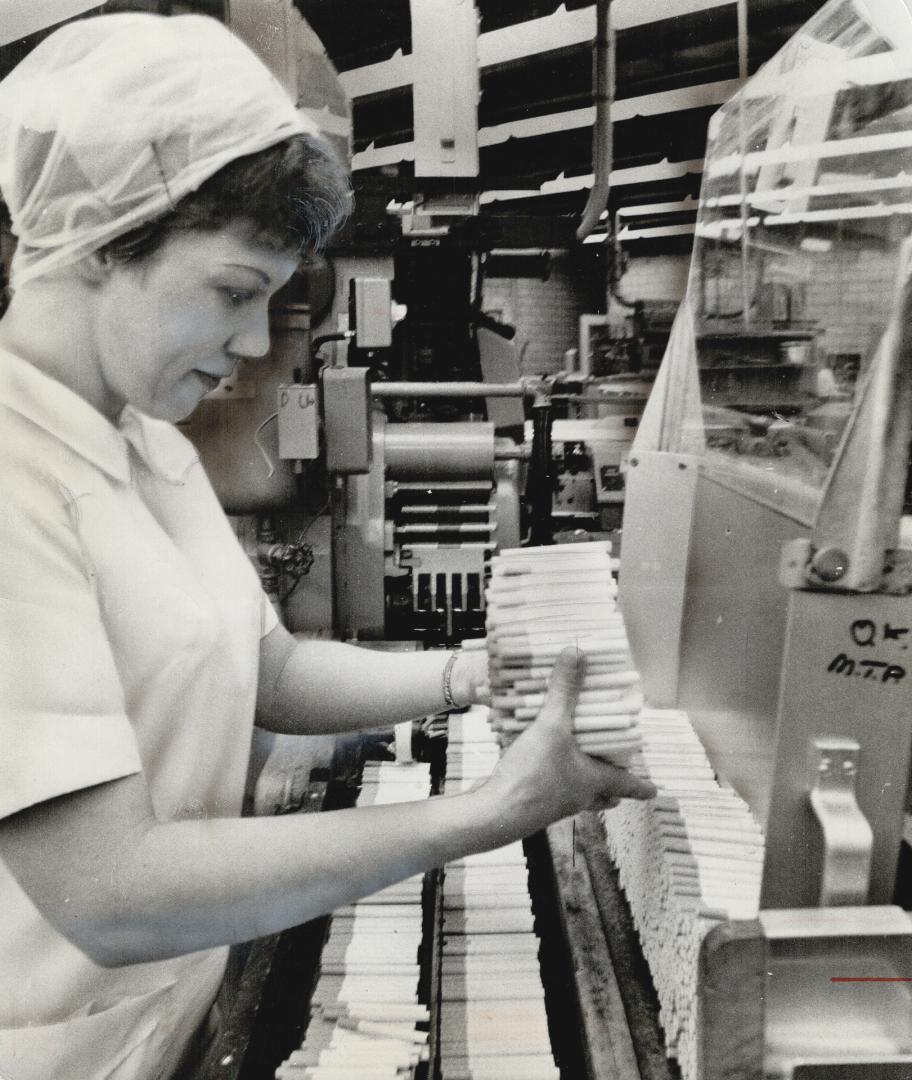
[0,13,317,285]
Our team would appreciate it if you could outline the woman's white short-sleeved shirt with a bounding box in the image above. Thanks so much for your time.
[0,351,276,1080]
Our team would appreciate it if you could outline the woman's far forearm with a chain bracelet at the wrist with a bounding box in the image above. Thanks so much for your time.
[257,626,487,734]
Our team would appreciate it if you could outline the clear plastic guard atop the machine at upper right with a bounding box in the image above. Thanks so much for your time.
[663,0,912,498]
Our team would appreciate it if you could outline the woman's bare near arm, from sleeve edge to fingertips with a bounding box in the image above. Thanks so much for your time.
[0,650,655,966]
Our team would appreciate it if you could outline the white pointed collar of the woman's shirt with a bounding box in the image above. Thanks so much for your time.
[0,349,199,484]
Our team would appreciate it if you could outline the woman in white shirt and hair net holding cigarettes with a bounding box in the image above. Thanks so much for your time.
[0,15,654,1080]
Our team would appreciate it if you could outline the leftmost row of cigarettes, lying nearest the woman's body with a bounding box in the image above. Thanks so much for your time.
[276,762,431,1080]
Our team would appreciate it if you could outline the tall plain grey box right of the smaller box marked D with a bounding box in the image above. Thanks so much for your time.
[322,367,372,475]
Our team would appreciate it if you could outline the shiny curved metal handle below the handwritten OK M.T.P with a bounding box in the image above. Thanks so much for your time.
[808,735,874,907]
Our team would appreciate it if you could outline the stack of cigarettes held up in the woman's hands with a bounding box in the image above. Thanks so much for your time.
[485,542,643,765]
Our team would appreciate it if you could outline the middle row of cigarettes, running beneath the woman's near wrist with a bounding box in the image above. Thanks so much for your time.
[440,706,560,1080]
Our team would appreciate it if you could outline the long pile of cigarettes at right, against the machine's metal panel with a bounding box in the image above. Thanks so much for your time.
[602,708,764,1080]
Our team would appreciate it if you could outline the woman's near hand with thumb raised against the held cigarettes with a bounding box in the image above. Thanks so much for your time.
[479,649,656,835]
